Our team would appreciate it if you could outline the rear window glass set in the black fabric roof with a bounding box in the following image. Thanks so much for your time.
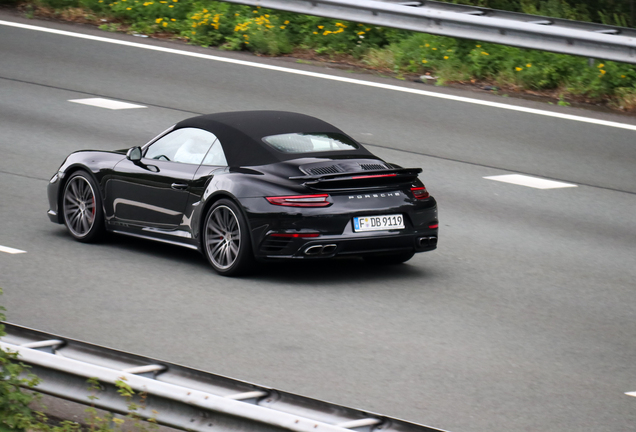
[263,133,359,153]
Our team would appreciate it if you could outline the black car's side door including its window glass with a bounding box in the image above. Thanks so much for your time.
[105,128,216,229]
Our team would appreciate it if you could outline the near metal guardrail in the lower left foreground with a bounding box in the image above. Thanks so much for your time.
[0,323,448,432]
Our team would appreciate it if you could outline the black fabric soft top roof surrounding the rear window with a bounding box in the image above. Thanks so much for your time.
[175,111,373,166]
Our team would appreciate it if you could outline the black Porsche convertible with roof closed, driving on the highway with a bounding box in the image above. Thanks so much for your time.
[48,111,438,276]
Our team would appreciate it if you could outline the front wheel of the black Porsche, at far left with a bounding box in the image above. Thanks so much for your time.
[62,171,104,243]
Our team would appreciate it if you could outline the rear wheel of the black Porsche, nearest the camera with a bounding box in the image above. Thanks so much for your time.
[202,199,255,276]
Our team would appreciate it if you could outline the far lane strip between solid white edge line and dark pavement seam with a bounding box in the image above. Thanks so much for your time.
[0,14,636,192]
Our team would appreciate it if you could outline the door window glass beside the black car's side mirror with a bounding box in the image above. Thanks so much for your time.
[144,128,216,165]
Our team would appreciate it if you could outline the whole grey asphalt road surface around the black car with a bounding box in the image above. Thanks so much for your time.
[0,14,636,432]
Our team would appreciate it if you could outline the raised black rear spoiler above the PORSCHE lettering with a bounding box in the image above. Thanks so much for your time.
[289,168,422,190]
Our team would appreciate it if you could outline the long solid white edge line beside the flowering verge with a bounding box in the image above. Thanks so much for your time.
[0,20,636,131]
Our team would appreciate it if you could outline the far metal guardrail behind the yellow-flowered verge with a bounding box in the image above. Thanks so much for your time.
[223,0,636,63]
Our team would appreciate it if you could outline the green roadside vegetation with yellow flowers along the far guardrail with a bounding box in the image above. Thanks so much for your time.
[0,0,636,112]
